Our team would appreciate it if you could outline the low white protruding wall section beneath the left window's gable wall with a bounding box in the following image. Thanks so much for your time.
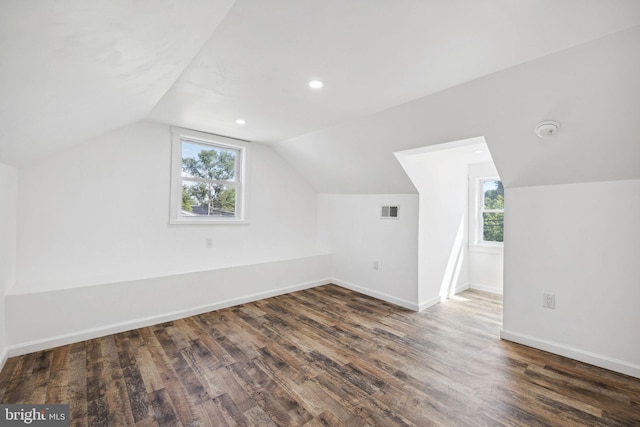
[6,255,331,356]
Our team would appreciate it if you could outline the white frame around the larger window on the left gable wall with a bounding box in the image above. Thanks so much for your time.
[169,127,251,225]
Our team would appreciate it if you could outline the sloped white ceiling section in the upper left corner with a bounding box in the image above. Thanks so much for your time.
[0,0,233,165]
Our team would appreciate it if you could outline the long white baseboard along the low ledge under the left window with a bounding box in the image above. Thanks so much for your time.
[3,279,332,358]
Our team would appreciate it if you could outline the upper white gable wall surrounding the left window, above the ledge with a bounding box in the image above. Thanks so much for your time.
[9,122,318,294]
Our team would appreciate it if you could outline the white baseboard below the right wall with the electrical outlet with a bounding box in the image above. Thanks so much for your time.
[500,329,640,378]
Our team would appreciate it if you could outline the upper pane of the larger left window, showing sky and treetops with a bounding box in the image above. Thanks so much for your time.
[182,140,238,181]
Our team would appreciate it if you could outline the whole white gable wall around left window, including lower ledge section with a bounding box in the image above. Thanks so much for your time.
[3,122,331,354]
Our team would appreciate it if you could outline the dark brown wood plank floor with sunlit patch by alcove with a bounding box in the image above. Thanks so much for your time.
[0,285,640,426]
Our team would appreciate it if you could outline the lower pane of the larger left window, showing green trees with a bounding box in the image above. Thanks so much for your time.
[182,181,236,217]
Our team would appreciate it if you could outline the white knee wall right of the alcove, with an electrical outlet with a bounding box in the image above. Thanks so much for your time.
[502,180,640,377]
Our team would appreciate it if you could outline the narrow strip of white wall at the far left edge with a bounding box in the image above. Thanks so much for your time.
[0,163,18,369]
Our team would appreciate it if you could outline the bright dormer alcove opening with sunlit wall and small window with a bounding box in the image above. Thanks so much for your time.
[395,137,504,310]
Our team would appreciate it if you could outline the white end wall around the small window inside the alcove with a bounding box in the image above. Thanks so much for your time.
[468,162,504,294]
